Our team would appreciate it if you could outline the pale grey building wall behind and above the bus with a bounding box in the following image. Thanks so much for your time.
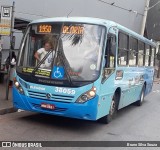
[0,0,145,47]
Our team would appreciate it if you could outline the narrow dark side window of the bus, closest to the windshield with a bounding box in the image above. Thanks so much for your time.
[105,34,116,68]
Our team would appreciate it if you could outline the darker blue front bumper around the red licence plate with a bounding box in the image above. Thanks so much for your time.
[13,87,98,120]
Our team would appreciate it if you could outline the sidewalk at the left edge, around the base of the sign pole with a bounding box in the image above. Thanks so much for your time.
[0,75,16,115]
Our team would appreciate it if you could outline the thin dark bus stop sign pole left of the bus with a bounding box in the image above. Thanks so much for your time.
[5,1,15,100]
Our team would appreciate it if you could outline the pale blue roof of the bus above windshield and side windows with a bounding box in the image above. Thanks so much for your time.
[30,17,156,47]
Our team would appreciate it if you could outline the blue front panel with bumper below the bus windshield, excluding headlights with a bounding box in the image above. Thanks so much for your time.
[13,79,99,120]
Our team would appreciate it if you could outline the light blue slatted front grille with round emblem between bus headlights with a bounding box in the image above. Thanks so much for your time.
[28,91,74,102]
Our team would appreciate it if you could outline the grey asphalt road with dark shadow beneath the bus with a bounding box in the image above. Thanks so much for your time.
[0,84,160,150]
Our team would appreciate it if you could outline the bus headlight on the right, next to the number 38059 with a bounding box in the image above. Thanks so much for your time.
[76,87,96,103]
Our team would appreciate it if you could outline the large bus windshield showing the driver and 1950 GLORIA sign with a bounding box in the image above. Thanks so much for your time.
[17,23,105,81]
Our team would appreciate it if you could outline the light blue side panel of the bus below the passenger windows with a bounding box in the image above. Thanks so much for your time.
[97,67,154,115]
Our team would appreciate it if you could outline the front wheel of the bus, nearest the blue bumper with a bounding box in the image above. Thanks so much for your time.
[98,95,118,124]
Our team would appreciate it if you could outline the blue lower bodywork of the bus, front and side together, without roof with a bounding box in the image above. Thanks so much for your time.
[13,67,154,120]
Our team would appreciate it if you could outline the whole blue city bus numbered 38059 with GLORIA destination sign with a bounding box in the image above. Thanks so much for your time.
[13,17,156,123]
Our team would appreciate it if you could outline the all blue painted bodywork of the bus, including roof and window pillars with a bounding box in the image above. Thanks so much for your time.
[13,17,155,120]
